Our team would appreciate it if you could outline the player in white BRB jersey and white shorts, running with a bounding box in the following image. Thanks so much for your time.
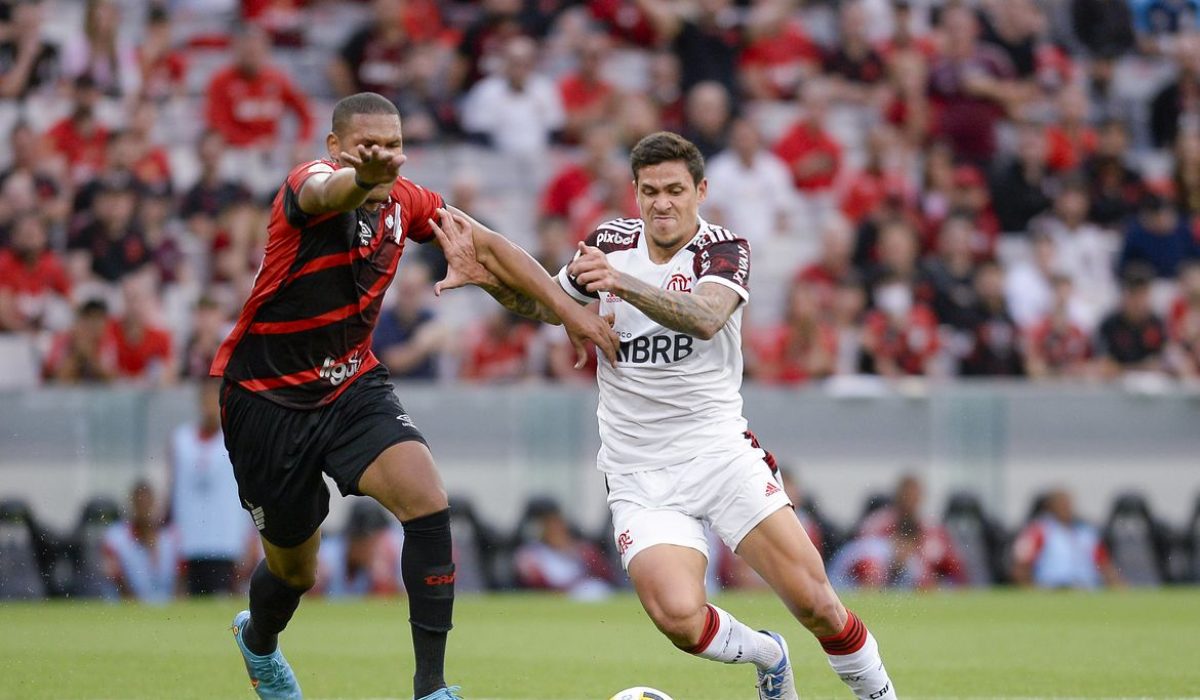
[436,132,896,700]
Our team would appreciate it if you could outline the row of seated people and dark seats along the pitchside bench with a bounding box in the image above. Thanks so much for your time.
[0,449,1200,603]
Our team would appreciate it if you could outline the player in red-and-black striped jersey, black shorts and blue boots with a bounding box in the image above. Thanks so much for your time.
[211,92,617,700]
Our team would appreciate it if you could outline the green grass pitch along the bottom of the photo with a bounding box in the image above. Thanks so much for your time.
[0,590,1200,700]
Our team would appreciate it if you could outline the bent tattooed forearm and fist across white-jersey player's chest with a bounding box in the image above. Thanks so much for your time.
[566,243,742,340]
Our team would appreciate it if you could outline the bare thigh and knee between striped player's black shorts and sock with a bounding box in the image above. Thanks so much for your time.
[358,441,449,522]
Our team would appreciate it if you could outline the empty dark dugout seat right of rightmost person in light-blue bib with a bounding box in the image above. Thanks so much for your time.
[1104,492,1171,586]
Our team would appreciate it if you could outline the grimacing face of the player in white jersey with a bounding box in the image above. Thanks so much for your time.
[634,161,708,252]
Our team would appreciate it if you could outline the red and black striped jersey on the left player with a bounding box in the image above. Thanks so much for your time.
[209,161,444,408]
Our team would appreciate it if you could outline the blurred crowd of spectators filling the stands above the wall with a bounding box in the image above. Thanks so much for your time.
[0,0,1200,384]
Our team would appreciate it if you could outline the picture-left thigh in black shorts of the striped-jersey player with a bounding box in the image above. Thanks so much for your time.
[221,384,329,549]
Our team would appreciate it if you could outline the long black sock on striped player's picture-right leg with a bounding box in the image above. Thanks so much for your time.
[400,509,455,698]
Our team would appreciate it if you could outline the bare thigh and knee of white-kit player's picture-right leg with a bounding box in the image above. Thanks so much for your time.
[736,508,846,636]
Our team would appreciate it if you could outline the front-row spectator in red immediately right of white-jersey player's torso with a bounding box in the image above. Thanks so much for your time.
[748,281,838,385]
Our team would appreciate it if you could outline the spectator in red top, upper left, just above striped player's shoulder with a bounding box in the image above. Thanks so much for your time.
[206,25,312,157]
